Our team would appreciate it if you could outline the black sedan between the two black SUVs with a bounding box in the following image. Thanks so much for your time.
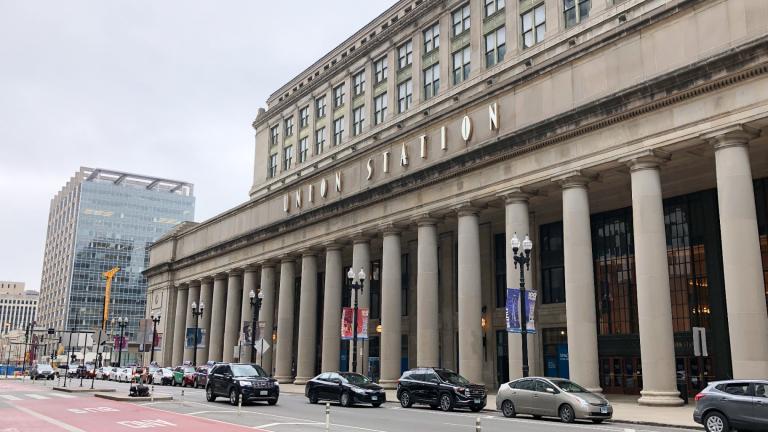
[304,372,387,408]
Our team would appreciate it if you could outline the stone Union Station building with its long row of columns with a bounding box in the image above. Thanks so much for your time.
[146,0,768,405]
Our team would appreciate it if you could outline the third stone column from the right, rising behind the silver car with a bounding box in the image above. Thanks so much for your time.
[555,173,604,393]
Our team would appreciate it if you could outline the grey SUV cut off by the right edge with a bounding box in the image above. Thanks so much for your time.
[693,380,768,432]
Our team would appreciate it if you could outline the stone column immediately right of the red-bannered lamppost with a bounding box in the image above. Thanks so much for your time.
[379,227,404,388]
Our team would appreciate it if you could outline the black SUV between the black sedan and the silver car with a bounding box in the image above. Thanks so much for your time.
[397,368,488,412]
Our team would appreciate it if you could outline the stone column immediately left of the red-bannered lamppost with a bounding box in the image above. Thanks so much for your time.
[322,243,344,371]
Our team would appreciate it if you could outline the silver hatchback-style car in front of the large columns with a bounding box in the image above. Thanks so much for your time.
[496,377,613,423]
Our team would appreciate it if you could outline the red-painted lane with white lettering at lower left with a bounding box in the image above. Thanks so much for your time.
[6,397,266,432]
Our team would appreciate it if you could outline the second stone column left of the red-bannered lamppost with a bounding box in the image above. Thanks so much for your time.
[293,251,317,385]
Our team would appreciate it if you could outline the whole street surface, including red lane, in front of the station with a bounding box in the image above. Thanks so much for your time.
[0,380,700,432]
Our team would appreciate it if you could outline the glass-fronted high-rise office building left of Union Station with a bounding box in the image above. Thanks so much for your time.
[38,168,195,341]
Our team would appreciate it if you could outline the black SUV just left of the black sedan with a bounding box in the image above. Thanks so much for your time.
[205,363,280,405]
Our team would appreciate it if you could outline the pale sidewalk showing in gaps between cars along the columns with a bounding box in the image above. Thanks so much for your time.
[280,384,702,429]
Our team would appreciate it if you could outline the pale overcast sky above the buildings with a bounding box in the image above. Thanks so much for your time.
[0,0,395,289]
